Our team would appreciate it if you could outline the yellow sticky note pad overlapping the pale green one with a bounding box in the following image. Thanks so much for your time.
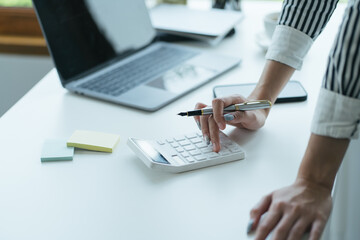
[67,130,120,152]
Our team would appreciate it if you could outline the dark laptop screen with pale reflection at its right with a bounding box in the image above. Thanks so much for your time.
[33,0,155,84]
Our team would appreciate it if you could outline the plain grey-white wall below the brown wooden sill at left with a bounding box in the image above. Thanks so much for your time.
[0,54,53,117]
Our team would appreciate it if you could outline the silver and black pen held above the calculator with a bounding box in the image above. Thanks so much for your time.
[178,100,272,117]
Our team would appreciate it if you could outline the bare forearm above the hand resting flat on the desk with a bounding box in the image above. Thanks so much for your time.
[297,134,350,190]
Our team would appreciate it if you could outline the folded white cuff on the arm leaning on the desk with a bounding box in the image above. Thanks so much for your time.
[311,88,360,139]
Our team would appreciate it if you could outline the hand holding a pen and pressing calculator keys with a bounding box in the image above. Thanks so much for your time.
[194,95,268,152]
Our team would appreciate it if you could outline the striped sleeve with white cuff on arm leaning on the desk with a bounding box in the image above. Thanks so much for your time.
[312,0,360,138]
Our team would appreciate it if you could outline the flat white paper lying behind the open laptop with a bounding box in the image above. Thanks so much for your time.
[150,4,242,37]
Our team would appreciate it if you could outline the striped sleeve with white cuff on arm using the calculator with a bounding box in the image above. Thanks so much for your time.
[266,0,338,70]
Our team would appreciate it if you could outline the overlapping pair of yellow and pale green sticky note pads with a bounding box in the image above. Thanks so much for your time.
[41,130,120,162]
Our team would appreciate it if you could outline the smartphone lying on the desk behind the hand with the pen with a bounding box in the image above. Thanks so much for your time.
[213,80,307,103]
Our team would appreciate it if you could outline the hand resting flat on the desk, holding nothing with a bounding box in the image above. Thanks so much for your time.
[248,179,332,240]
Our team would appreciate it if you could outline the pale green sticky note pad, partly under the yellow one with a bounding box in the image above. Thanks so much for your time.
[41,139,74,162]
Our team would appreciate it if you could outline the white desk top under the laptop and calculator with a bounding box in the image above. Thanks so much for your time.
[0,2,343,240]
